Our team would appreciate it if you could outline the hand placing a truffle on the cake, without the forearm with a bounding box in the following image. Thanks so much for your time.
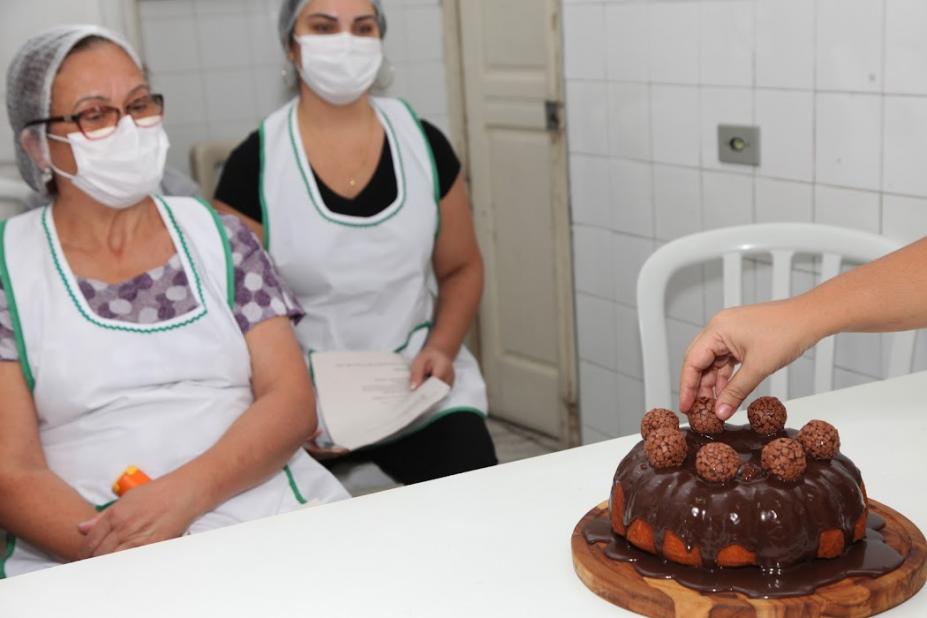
[679,299,816,420]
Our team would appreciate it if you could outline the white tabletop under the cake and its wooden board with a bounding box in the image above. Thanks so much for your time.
[0,372,927,618]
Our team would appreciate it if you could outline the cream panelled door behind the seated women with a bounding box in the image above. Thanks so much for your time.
[454,0,576,445]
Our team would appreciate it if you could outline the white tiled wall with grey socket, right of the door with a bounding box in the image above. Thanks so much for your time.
[563,0,927,441]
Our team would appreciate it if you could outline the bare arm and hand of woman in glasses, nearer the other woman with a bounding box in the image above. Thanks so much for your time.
[81,317,316,557]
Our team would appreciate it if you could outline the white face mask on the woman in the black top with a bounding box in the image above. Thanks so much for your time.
[296,32,383,105]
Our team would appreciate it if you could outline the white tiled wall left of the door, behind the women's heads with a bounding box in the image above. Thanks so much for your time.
[140,0,448,183]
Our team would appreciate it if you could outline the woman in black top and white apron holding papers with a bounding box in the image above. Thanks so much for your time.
[216,0,496,483]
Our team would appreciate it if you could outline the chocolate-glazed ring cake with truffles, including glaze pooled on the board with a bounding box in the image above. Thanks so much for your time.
[583,397,902,597]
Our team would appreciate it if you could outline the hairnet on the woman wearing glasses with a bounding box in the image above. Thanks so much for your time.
[6,25,142,195]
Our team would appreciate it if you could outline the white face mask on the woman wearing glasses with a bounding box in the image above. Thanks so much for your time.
[48,116,170,208]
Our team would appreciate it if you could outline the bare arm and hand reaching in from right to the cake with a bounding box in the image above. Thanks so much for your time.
[679,239,927,420]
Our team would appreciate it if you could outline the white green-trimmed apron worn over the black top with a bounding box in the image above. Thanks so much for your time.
[260,98,487,441]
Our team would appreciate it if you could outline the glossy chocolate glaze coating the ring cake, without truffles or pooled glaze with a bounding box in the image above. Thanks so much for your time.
[614,425,866,569]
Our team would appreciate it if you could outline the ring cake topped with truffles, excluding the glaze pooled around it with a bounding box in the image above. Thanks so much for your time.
[610,397,867,569]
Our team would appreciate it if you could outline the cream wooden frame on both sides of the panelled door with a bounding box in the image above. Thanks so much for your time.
[441,0,581,448]
